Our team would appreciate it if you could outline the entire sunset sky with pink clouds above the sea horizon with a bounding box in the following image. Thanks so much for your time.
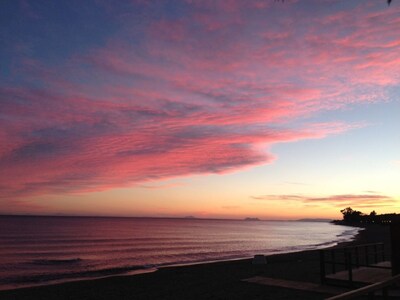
[0,0,400,219]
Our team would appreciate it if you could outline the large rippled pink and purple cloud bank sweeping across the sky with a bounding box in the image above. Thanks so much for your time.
[0,1,400,197]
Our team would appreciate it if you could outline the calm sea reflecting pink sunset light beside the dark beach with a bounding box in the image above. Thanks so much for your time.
[0,217,358,289]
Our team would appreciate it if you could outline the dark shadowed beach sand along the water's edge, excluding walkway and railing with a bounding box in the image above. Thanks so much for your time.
[0,225,390,299]
